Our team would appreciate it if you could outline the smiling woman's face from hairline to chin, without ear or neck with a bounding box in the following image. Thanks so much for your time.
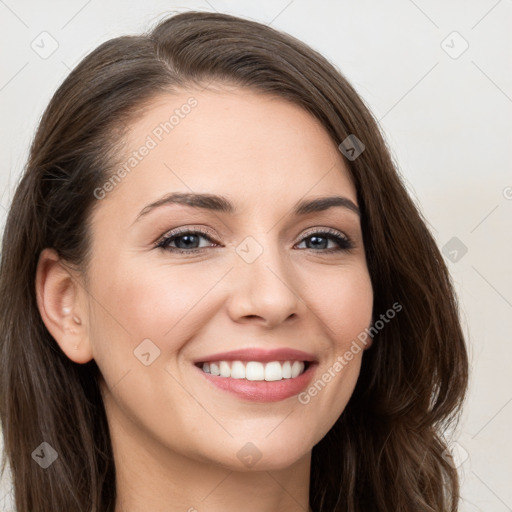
[84,88,373,470]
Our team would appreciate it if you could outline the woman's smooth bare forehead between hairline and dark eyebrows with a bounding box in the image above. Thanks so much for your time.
[95,87,356,216]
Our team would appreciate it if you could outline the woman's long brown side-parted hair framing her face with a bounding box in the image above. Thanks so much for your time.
[0,12,468,512]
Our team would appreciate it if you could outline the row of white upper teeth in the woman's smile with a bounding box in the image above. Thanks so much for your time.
[202,361,305,381]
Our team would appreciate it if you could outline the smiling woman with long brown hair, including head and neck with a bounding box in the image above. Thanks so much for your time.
[0,12,468,512]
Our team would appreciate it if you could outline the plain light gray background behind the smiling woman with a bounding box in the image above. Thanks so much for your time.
[0,0,512,512]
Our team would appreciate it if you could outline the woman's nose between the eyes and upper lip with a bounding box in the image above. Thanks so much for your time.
[227,236,302,328]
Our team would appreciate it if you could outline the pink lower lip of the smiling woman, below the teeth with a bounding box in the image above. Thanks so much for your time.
[195,363,317,402]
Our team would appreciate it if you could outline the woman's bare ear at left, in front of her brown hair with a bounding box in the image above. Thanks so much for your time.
[35,249,93,364]
